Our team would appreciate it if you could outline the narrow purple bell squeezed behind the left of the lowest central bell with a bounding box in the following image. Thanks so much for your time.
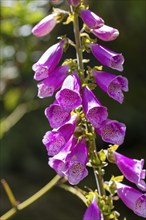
[48,136,77,176]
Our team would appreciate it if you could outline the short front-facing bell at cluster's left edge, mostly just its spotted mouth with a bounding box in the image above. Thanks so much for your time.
[45,101,70,128]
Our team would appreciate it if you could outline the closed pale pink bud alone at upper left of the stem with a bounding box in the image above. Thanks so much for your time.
[32,14,57,37]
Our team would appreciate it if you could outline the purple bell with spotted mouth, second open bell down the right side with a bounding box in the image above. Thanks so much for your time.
[92,70,128,103]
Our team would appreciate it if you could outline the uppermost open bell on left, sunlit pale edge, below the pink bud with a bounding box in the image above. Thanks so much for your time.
[32,40,65,80]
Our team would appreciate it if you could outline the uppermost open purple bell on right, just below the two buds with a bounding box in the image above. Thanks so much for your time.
[90,43,124,71]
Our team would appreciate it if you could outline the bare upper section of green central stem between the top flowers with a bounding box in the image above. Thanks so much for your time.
[71,6,84,70]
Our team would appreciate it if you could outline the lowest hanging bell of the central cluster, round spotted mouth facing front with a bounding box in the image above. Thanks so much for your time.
[64,139,88,185]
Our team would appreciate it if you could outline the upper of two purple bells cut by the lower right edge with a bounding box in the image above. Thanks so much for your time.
[114,152,146,191]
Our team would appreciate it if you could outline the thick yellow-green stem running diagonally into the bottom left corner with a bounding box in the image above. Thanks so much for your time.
[0,175,61,220]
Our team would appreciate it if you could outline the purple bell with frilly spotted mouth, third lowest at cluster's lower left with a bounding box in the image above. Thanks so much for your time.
[42,115,77,156]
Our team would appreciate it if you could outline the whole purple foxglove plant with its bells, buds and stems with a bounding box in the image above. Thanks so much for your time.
[2,0,146,220]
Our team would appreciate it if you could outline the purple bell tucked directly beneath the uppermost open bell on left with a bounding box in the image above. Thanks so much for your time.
[37,65,69,98]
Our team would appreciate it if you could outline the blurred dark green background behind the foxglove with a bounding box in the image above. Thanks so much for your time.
[0,0,146,220]
